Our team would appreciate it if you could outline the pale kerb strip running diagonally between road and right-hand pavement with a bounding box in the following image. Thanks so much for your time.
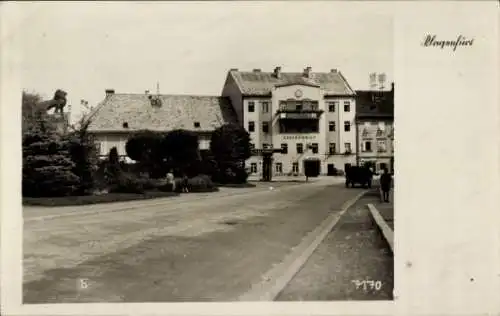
[237,190,368,301]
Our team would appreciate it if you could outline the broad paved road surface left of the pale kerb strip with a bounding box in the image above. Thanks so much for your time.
[23,179,390,304]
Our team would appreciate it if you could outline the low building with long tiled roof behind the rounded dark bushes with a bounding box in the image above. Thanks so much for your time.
[89,90,237,158]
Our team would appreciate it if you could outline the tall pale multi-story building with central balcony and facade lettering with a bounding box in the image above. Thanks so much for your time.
[222,67,357,175]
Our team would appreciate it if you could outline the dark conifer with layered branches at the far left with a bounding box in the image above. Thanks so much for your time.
[22,117,80,197]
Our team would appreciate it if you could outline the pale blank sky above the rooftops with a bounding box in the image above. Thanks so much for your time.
[8,1,393,120]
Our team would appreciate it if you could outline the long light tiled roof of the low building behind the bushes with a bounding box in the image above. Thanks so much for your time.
[89,93,237,132]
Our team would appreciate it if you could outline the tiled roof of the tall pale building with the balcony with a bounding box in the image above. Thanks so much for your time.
[229,70,354,96]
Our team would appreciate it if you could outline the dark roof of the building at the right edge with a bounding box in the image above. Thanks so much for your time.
[356,90,394,119]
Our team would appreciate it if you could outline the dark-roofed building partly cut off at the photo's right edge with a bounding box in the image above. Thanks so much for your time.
[356,83,394,172]
